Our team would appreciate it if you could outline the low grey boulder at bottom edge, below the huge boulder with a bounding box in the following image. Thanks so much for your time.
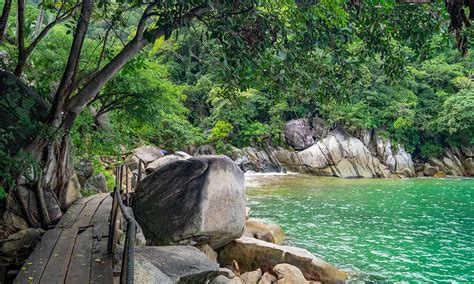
[134,246,219,284]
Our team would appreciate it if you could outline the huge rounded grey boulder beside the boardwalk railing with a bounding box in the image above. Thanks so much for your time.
[132,156,246,249]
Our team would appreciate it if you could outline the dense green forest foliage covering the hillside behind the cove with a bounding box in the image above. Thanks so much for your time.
[2,0,474,169]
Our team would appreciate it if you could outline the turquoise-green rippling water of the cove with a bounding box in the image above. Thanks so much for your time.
[247,175,474,283]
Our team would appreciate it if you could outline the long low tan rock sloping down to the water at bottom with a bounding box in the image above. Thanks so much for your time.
[218,237,347,282]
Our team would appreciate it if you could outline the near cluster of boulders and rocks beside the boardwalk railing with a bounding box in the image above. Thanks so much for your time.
[118,150,347,284]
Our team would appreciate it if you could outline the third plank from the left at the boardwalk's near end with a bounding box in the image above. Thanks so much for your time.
[65,227,93,284]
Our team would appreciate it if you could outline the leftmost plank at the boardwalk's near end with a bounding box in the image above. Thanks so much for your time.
[14,229,61,283]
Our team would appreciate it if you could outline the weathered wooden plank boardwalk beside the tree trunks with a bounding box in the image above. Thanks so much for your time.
[14,193,113,284]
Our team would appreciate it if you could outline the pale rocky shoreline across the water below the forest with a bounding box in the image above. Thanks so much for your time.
[228,119,474,178]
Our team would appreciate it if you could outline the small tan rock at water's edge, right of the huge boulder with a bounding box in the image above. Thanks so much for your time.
[244,219,285,244]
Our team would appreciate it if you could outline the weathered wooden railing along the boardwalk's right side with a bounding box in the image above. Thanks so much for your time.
[107,157,144,284]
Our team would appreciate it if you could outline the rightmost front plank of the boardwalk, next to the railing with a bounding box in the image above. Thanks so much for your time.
[90,234,113,284]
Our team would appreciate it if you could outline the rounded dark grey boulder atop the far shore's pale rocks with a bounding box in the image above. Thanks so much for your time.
[285,118,314,150]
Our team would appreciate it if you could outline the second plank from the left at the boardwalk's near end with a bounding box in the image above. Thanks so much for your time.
[40,228,77,284]
